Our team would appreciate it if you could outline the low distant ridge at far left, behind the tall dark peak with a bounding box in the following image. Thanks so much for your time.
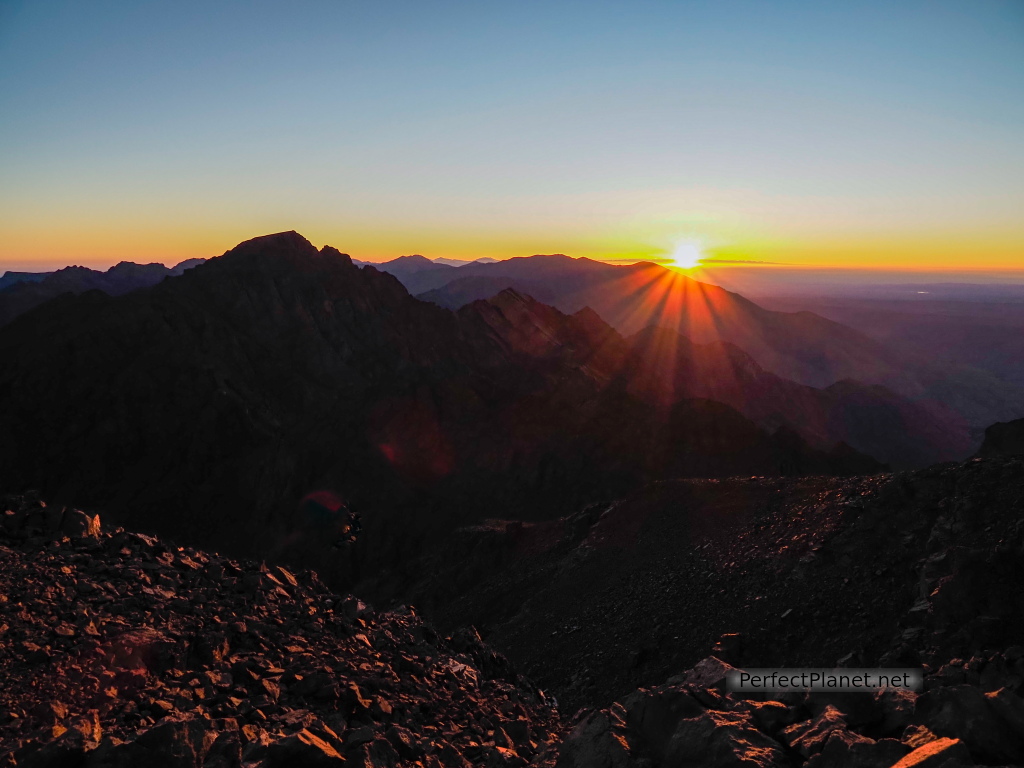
[0,259,206,326]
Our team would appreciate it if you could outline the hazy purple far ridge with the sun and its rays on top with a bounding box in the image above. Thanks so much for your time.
[411,255,1024,438]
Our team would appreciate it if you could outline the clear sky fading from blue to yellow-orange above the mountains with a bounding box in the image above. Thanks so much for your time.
[0,0,1024,270]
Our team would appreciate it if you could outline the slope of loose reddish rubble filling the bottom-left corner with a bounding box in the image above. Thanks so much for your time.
[0,497,560,768]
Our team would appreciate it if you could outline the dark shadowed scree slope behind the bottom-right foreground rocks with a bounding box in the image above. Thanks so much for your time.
[403,457,1024,714]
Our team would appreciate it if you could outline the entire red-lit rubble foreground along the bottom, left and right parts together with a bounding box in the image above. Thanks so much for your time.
[0,487,1024,768]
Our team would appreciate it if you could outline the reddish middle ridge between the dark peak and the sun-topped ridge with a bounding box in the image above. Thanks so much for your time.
[452,289,970,468]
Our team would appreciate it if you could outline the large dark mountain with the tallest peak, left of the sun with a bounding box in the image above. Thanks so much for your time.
[0,232,879,567]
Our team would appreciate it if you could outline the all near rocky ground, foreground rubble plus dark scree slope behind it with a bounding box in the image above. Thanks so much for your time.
[0,457,1024,768]
